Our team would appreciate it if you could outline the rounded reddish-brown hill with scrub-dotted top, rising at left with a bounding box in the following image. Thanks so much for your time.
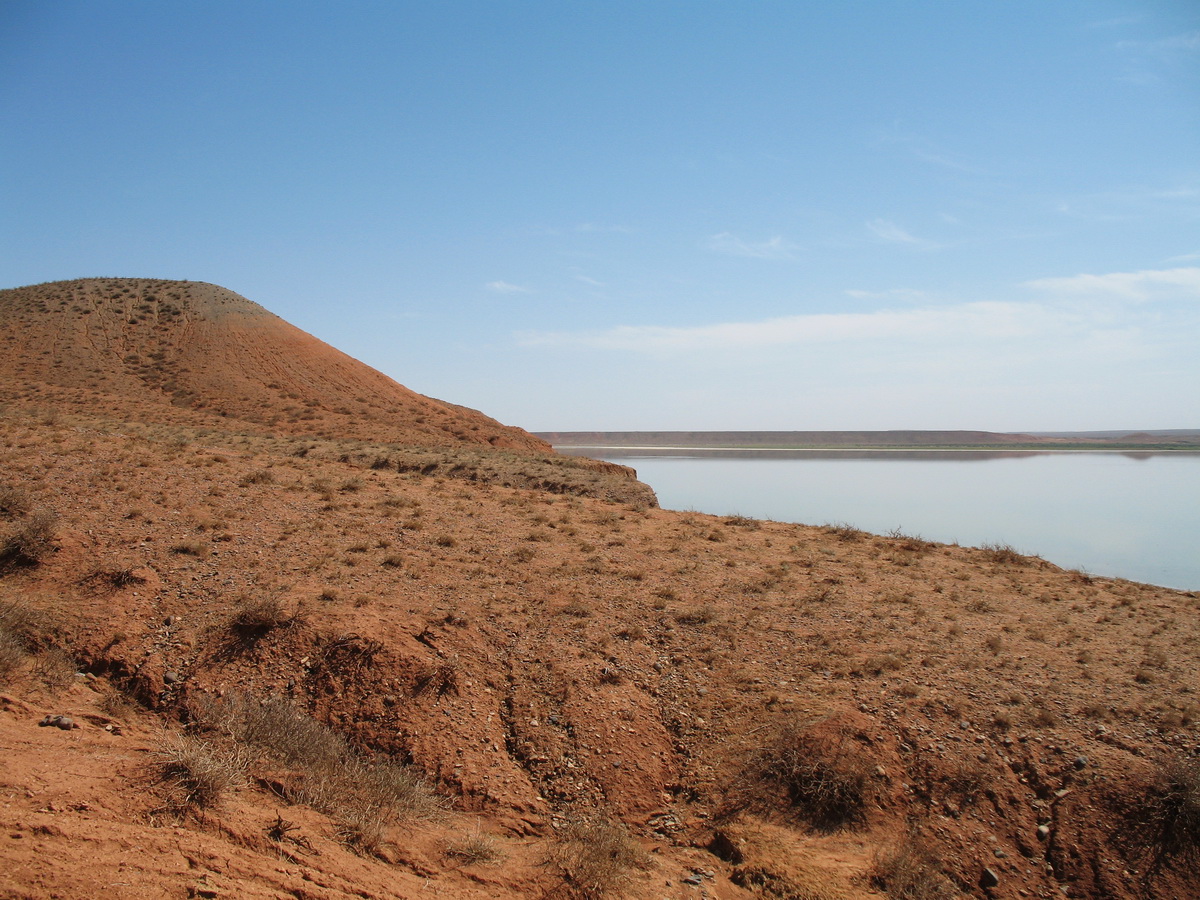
[0,278,550,452]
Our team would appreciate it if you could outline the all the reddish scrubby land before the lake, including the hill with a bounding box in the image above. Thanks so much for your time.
[0,278,1200,900]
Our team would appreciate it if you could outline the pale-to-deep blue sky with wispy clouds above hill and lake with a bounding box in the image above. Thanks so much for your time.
[0,0,1200,431]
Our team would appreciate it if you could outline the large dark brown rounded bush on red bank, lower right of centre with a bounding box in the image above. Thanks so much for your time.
[749,719,875,830]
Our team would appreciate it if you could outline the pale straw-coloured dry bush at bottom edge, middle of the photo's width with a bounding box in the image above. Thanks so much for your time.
[544,818,647,900]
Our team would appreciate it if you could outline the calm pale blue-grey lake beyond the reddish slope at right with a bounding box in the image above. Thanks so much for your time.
[559,448,1200,590]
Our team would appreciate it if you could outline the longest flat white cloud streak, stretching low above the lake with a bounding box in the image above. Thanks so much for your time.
[517,302,1069,352]
